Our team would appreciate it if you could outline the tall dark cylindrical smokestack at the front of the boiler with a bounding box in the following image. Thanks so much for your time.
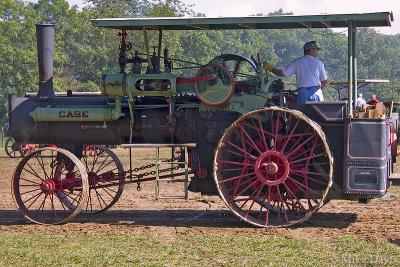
[36,24,55,97]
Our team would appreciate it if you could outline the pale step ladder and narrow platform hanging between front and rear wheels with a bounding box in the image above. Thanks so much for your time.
[121,143,196,200]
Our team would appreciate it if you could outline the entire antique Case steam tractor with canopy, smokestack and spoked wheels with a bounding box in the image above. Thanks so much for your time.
[9,13,397,227]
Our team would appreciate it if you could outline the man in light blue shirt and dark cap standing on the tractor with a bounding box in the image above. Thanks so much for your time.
[264,41,328,104]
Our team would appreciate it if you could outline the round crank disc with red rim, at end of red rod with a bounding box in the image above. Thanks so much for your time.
[194,64,236,106]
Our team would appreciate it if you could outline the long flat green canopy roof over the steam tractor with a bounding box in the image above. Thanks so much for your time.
[92,12,393,30]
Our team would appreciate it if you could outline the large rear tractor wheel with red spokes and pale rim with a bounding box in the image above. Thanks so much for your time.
[214,107,333,227]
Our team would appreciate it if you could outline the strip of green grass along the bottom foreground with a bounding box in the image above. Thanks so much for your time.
[0,233,400,266]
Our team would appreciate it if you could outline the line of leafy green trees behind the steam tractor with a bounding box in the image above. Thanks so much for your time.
[0,0,400,122]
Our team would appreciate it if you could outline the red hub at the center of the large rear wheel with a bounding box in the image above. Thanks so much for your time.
[254,151,290,186]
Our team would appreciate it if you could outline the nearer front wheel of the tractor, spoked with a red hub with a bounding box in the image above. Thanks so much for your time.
[12,147,89,224]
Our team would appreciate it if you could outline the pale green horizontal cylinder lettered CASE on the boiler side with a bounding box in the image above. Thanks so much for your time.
[30,107,124,122]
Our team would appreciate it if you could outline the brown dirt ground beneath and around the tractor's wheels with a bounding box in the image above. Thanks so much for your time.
[0,150,400,244]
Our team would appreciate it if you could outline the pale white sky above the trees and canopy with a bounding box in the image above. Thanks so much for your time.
[68,0,400,34]
